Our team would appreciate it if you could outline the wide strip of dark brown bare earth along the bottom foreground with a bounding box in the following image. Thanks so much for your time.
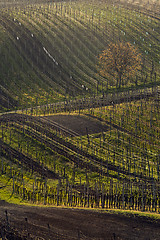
[0,201,160,240]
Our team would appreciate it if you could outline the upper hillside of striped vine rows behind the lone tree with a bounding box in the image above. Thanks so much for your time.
[0,1,160,111]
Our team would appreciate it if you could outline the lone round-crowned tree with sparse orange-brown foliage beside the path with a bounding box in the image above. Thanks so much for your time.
[98,41,142,88]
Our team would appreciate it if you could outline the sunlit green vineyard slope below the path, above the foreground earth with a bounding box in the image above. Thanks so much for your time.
[0,89,160,212]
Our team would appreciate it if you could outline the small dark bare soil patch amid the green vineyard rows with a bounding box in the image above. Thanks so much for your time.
[45,115,108,135]
